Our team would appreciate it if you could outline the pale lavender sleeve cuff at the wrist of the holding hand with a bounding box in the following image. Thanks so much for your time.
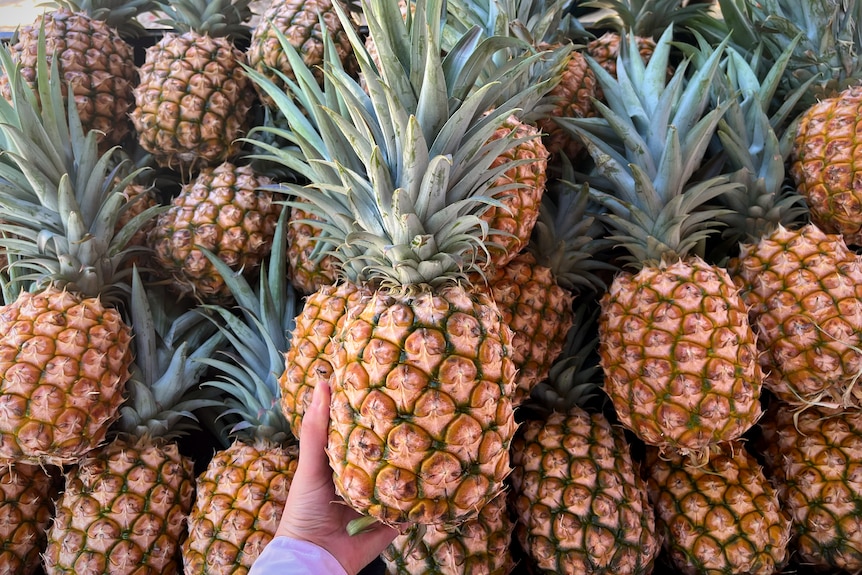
[248,537,347,575]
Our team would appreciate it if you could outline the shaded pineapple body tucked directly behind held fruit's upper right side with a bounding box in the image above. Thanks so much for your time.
[488,252,574,407]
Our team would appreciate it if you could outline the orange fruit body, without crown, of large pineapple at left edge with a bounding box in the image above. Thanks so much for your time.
[0,287,132,465]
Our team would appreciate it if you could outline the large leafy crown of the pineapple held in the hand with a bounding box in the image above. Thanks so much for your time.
[251,0,550,288]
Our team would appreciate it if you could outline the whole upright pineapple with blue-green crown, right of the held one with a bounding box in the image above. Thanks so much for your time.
[559,27,763,460]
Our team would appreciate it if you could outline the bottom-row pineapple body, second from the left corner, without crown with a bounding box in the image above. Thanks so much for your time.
[44,437,194,575]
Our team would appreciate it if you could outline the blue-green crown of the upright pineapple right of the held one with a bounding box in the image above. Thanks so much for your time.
[557,26,737,266]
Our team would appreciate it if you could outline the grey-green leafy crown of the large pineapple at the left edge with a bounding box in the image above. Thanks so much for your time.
[0,29,160,301]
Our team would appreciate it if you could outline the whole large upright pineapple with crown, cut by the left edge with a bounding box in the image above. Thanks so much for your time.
[0,38,159,464]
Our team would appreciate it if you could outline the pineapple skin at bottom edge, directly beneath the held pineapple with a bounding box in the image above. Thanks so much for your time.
[381,492,515,575]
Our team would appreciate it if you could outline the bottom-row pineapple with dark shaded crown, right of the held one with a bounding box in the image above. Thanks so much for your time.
[509,302,661,575]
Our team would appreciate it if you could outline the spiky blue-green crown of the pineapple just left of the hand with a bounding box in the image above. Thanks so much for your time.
[198,210,298,443]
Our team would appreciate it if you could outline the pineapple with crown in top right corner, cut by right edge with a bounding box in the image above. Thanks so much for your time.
[718,0,862,245]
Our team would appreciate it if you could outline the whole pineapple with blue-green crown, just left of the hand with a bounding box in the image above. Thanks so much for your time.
[182,212,299,575]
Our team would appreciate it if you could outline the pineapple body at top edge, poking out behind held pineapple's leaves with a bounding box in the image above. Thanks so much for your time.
[246,0,358,106]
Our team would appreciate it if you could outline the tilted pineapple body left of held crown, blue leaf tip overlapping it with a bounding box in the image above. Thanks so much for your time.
[147,162,282,302]
